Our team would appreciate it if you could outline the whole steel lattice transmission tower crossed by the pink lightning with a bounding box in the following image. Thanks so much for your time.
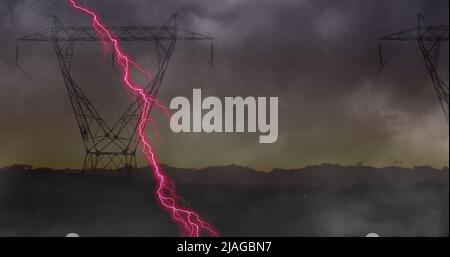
[17,15,213,172]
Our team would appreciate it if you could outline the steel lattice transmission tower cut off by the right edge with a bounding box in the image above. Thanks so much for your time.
[378,14,449,123]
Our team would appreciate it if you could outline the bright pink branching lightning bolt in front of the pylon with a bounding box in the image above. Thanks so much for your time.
[69,0,219,237]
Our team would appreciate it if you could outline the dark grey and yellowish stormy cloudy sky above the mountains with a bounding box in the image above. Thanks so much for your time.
[0,0,448,169]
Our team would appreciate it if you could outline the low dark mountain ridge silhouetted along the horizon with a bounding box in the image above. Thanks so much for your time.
[0,164,449,187]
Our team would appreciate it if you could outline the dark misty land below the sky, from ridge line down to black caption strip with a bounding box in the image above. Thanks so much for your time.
[0,165,449,236]
